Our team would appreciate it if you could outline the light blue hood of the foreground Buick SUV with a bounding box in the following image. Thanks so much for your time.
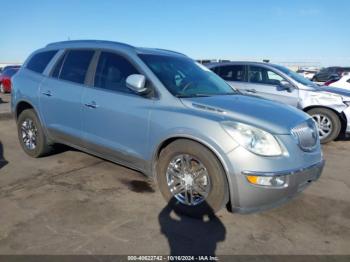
[181,95,310,134]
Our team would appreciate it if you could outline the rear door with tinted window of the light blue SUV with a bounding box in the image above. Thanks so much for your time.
[40,49,95,146]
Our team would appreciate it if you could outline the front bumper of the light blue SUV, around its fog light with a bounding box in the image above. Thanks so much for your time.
[232,160,325,213]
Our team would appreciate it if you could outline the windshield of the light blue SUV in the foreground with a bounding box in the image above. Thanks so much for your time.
[139,55,238,97]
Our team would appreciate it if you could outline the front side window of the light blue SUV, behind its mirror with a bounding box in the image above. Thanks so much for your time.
[95,52,138,93]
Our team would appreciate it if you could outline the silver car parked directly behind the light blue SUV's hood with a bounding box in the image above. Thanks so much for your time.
[208,62,350,143]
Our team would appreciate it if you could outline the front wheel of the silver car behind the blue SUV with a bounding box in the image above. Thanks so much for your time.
[307,108,341,144]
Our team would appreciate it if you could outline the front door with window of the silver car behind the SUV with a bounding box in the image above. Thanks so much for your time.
[246,65,299,107]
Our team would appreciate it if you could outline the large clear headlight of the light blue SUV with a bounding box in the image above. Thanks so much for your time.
[222,121,282,156]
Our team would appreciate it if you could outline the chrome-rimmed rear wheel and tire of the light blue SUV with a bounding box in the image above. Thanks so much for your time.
[17,109,52,158]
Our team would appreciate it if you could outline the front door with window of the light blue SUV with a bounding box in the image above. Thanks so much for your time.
[82,51,154,169]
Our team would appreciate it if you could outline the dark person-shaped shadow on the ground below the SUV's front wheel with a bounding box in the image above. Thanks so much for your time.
[158,198,226,256]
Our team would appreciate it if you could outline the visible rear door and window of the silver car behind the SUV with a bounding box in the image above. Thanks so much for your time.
[212,65,246,92]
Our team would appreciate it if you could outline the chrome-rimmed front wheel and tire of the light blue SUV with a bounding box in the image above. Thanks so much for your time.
[157,139,229,217]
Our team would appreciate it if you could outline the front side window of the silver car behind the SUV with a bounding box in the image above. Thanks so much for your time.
[248,66,284,85]
